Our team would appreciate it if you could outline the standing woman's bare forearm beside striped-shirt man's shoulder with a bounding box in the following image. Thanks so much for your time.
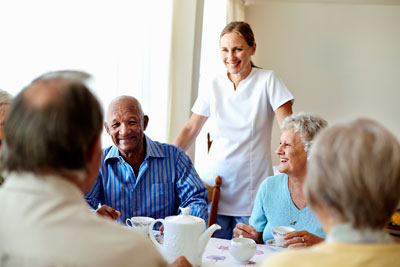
[174,113,208,151]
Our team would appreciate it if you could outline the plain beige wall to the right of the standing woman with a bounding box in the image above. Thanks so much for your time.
[246,1,400,164]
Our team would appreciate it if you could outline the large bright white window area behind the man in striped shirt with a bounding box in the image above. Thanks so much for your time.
[0,0,172,147]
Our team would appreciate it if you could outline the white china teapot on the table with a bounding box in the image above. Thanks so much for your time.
[149,207,221,266]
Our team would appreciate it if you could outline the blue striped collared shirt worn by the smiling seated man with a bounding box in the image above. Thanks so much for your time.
[85,136,208,223]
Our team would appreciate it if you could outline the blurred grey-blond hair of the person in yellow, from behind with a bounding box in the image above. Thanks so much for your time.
[304,119,400,230]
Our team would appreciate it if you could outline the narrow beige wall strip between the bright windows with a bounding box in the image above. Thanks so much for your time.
[168,0,203,159]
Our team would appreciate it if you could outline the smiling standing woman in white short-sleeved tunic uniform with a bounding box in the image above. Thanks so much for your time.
[175,22,294,239]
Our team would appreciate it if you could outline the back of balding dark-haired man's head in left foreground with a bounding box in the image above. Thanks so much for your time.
[0,71,103,176]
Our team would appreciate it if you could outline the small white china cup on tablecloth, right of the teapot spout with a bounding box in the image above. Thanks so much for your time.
[229,236,256,264]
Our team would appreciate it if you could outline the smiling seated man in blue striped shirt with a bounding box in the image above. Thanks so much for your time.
[85,96,208,223]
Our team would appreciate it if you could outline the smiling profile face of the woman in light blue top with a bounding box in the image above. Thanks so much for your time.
[276,129,307,176]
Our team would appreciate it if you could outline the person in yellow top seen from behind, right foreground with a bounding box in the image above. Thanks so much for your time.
[265,119,400,267]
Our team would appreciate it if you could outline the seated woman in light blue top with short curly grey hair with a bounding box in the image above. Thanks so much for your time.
[234,113,327,247]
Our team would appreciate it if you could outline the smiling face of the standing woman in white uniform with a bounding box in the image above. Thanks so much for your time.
[220,32,256,75]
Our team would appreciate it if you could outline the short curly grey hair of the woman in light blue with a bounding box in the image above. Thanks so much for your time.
[281,112,328,152]
